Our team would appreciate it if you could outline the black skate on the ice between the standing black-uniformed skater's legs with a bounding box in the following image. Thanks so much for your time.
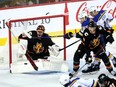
[82,63,100,73]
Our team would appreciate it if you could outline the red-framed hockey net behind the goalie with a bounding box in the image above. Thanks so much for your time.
[2,15,66,72]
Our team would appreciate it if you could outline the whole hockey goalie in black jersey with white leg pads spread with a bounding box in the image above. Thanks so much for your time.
[11,25,68,72]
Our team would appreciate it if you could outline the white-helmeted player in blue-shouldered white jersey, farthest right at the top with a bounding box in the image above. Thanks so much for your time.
[89,6,113,29]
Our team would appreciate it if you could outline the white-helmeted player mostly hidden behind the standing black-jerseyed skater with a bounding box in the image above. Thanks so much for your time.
[78,11,114,73]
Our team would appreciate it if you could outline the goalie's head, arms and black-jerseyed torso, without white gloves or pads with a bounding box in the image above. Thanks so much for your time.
[19,25,58,60]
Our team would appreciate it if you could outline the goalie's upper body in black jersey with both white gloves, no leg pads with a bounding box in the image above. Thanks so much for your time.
[18,25,59,60]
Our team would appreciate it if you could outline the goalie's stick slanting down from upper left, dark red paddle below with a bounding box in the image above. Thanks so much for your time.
[6,22,38,71]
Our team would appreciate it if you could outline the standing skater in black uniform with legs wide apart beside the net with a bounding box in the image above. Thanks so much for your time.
[64,21,116,76]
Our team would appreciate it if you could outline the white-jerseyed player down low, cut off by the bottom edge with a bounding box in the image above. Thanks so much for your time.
[59,75,100,87]
